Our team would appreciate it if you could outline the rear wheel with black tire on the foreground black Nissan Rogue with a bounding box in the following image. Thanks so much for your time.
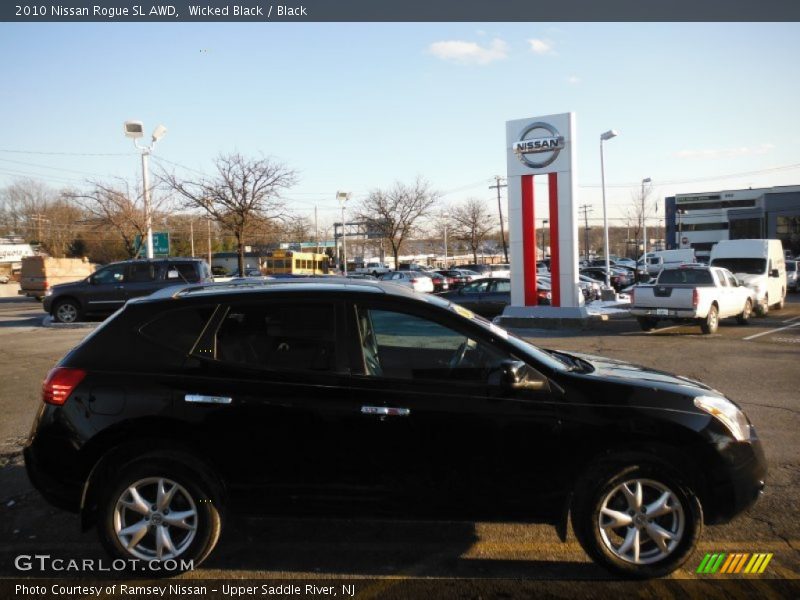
[98,455,222,576]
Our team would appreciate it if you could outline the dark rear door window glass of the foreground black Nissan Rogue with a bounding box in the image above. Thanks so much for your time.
[215,303,335,371]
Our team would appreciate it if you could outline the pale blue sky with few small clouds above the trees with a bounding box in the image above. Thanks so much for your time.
[0,23,800,227]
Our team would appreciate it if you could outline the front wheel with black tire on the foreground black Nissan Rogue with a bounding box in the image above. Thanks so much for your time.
[571,458,703,579]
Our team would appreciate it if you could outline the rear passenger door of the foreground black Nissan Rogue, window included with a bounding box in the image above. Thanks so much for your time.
[176,295,366,511]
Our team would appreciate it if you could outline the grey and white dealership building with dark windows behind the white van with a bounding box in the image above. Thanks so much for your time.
[664,185,800,258]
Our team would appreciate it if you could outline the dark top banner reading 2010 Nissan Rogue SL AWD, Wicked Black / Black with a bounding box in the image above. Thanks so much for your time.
[0,0,800,23]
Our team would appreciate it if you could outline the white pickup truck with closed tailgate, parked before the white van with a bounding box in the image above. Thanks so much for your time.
[631,265,755,333]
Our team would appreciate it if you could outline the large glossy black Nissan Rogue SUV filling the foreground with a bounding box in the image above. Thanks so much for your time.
[24,278,766,577]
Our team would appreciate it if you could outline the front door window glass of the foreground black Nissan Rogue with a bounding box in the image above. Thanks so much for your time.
[357,307,510,383]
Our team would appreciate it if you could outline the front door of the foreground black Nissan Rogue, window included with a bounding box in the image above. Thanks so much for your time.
[348,299,560,518]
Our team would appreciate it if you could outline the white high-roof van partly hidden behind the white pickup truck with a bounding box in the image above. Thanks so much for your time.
[711,240,786,315]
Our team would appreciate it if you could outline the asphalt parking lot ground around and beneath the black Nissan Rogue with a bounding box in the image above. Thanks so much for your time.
[0,295,800,597]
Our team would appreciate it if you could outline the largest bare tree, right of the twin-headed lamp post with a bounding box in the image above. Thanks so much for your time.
[161,153,297,273]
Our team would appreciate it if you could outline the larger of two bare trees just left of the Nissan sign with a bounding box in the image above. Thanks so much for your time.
[356,178,438,268]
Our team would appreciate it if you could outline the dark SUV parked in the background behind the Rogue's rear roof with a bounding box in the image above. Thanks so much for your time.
[43,258,213,323]
